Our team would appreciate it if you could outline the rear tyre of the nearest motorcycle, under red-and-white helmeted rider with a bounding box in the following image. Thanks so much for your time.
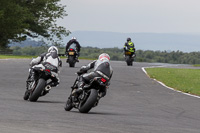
[79,89,98,113]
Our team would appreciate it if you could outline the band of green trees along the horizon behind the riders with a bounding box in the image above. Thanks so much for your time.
[10,46,200,64]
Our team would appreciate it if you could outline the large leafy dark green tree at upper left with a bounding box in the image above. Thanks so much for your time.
[0,0,69,49]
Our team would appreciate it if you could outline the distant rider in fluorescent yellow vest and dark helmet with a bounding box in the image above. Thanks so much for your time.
[124,37,136,58]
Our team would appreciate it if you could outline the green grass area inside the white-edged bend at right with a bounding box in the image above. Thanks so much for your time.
[145,68,200,96]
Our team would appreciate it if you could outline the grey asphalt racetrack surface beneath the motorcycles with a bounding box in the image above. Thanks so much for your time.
[0,59,200,133]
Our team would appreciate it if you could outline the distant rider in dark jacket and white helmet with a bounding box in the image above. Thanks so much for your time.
[65,37,81,62]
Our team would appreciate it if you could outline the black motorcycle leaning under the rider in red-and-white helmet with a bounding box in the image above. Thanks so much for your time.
[65,72,108,113]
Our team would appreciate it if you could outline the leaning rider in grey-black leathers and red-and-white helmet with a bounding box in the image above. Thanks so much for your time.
[72,53,113,97]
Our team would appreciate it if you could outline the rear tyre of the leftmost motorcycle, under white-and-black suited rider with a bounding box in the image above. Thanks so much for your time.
[29,79,46,102]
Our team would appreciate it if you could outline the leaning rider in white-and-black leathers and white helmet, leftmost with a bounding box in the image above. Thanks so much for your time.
[27,46,62,90]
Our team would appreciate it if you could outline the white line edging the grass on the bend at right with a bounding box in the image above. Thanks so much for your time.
[142,66,200,98]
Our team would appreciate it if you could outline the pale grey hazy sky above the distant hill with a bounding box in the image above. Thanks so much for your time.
[58,0,200,33]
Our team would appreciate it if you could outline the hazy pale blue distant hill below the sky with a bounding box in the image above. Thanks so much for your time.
[64,31,200,52]
